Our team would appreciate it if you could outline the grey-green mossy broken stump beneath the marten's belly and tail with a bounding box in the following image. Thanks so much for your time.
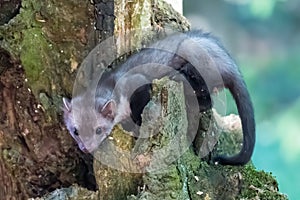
[128,79,287,200]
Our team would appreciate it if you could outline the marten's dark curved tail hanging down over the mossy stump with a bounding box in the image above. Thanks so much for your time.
[214,75,255,165]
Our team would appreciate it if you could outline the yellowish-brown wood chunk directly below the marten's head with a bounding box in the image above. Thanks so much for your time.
[93,125,142,200]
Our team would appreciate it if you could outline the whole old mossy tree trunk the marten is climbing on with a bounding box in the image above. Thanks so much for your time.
[0,0,285,200]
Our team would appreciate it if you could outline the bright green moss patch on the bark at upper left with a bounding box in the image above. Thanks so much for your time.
[1,0,51,97]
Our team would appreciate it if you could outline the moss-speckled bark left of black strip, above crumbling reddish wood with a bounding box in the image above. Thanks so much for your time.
[0,0,95,120]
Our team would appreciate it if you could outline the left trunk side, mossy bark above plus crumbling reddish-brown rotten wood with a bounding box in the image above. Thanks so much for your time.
[0,0,95,199]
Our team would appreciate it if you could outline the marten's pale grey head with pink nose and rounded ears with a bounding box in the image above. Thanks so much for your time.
[63,96,116,153]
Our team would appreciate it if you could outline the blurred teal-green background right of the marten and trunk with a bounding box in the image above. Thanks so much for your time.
[183,0,300,200]
